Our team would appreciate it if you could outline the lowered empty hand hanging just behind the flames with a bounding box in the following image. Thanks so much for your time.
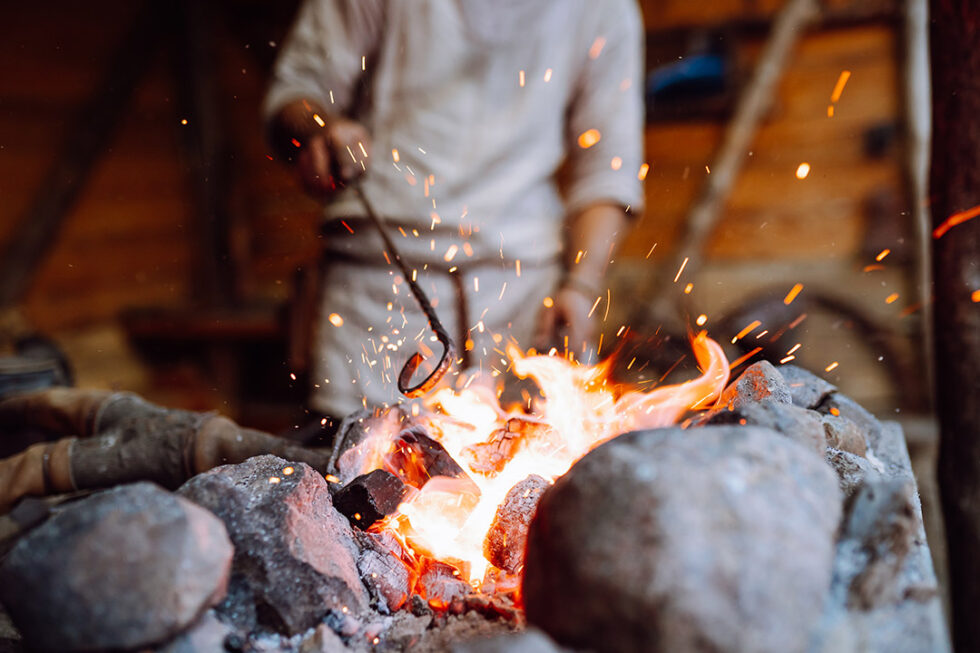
[534,284,599,359]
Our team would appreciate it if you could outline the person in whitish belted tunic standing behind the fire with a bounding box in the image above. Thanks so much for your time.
[265,0,643,417]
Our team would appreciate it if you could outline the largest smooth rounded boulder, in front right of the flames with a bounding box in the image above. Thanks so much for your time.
[523,426,841,653]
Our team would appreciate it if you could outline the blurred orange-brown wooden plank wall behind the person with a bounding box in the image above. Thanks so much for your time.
[0,0,915,416]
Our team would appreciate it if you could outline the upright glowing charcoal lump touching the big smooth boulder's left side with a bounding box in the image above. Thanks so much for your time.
[483,474,551,572]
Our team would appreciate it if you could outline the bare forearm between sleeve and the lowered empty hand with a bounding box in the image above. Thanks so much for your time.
[563,203,629,294]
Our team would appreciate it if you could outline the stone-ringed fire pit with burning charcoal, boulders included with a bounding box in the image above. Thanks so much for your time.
[0,333,948,652]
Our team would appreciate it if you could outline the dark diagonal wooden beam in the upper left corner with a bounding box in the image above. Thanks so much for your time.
[0,0,163,307]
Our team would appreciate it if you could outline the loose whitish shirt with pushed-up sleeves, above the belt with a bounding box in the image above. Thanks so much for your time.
[265,0,643,265]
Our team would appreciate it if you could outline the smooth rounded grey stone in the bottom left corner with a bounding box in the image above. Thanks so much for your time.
[0,483,232,651]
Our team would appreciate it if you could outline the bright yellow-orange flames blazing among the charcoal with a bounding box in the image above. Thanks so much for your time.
[361,331,729,587]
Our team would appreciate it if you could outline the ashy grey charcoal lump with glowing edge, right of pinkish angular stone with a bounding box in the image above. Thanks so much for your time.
[355,531,417,613]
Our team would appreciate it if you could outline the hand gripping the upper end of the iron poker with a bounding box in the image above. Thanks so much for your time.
[296,118,371,199]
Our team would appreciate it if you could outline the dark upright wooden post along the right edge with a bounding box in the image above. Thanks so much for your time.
[930,0,980,651]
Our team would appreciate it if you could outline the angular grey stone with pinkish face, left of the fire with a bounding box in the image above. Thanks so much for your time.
[179,455,368,635]
